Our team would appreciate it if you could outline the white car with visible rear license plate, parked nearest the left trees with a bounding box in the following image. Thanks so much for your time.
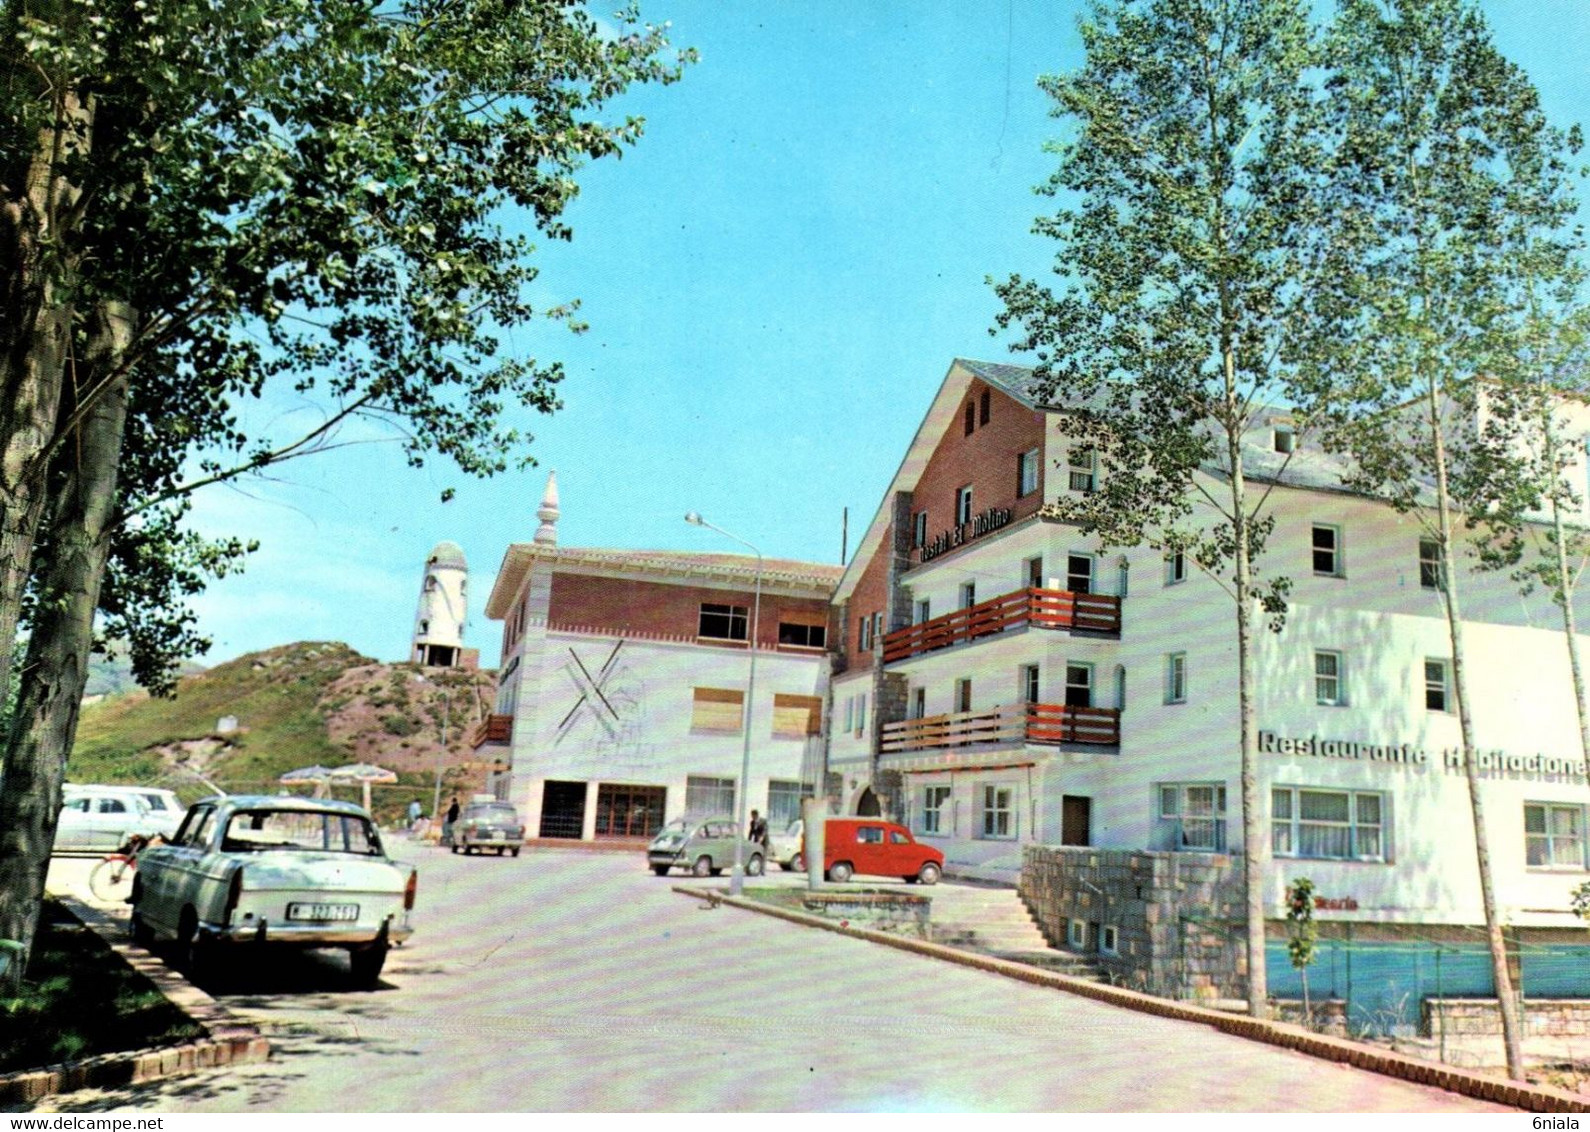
[129,795,418,986]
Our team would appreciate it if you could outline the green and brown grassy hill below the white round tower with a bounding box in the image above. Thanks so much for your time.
[67,642,496,817]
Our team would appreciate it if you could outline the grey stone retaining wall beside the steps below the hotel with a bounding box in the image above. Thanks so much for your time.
[1018,846,1248,1000]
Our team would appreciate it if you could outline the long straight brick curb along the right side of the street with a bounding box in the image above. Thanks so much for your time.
[674,884,1590,1113]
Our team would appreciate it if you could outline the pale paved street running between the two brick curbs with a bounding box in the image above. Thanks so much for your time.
[34,841,1487,1111]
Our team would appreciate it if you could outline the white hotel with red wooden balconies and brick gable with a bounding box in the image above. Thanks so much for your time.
[827,361,1590,938]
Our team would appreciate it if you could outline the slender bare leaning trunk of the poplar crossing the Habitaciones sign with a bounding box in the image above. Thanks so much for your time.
[1428,380,1523,1081]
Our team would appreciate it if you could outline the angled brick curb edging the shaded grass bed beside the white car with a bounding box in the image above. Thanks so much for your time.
[0,895,270,1103]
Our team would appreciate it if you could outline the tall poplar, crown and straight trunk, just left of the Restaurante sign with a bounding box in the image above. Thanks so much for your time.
[997,0,1323,1016]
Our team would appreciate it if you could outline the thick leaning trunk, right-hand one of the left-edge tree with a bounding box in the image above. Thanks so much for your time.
[0,304,132,951]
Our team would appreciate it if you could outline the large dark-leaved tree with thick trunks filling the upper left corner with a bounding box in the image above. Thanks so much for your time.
[0,0,685,966]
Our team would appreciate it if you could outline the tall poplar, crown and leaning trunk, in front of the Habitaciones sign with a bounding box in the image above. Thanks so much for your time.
[1313,0,1573,1078]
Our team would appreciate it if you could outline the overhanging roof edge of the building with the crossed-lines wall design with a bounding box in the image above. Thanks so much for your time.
[487,542,844,620]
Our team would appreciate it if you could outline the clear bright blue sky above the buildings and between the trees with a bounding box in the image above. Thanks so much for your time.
[194,0,1590,665]
